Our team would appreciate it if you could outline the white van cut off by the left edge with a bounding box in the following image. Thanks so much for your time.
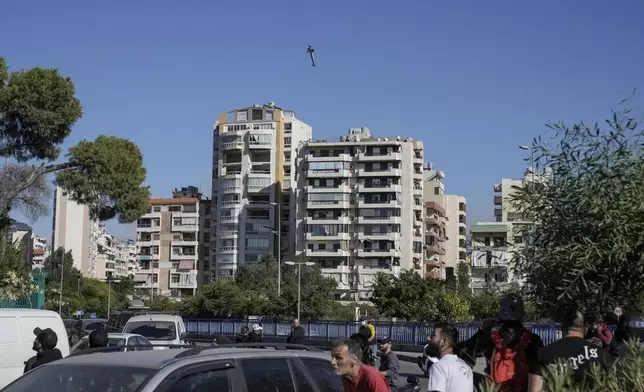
[0,309,69,389]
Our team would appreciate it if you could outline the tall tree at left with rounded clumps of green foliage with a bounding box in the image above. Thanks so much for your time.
[0,57,150,228]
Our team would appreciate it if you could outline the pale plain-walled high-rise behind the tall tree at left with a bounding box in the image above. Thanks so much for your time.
[52,187,100,277]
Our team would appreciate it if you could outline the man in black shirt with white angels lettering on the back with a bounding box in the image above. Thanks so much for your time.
[530,308,611,392]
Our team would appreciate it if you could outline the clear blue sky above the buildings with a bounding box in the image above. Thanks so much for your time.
[0,0,644,237]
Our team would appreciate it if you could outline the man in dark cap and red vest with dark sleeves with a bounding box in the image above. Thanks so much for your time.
[458,294,543,392]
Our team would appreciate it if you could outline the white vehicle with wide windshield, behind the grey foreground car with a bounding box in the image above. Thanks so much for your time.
[123,313,186,350]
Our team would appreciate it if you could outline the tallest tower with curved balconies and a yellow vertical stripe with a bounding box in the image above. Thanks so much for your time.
[211,103,311,280]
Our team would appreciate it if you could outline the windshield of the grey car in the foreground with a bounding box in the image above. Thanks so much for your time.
[2,364,154,392]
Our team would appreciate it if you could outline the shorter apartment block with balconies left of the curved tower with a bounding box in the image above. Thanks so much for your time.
[134,197,200,299]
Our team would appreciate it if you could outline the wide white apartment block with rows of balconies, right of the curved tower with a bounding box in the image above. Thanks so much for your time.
[296,128,424,301]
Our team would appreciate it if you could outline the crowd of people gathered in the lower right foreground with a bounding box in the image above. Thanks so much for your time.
[331,295,644,392]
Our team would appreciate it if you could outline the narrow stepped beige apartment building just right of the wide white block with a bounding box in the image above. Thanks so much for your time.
[423,165,467,279]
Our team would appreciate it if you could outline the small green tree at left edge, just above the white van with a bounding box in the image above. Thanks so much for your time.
[0,231,35,300]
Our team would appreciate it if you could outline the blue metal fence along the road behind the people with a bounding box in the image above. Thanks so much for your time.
[185,319,560,345]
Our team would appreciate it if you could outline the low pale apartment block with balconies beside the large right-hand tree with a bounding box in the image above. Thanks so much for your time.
[470,222,514,294]
